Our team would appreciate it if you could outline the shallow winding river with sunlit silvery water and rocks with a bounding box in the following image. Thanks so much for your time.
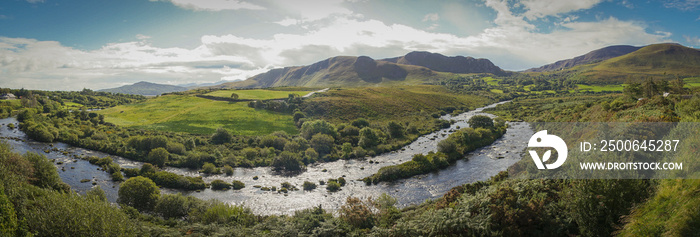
[0,102,533,215]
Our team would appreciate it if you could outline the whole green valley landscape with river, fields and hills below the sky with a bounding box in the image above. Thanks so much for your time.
[0,44,700,236]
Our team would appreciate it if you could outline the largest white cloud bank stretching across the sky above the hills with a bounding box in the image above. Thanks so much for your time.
[0,0,676,90]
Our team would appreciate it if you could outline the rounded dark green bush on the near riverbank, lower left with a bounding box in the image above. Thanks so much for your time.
[117,176,160,212]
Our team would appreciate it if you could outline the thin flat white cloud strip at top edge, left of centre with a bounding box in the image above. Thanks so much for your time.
[149,0,265,11]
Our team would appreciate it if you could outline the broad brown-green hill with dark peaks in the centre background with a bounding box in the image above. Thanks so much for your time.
[209,52,505,88]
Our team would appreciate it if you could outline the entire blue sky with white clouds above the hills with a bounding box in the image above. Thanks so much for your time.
[0,0,700,90]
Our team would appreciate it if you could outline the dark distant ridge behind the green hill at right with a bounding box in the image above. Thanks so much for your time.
[525,45,641,72]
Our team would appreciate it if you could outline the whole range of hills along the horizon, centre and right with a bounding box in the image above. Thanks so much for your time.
[100,43,700,92]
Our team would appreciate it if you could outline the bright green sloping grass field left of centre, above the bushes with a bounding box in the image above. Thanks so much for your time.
[99,95,298,135]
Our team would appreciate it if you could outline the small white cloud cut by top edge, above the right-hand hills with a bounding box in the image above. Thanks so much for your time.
[520,0,602,20]
